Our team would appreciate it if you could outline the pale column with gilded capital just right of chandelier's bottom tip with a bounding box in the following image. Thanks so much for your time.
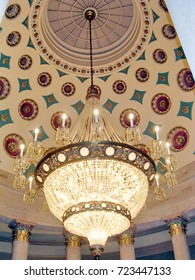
[118,229,135,260]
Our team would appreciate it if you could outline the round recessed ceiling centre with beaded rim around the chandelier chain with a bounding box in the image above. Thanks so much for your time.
[29,0,153,76]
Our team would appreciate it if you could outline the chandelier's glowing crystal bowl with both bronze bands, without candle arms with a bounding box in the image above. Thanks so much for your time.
[36,141,155,246]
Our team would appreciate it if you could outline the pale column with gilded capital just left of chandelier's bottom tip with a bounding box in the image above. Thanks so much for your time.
[65,234,81,260]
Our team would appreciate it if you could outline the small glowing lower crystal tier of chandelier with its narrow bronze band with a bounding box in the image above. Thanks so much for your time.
[63,201,131,247]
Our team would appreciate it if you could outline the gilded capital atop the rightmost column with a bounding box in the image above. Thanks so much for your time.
[165,216,188,237]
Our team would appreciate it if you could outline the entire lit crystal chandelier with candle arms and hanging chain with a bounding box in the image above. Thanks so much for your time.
[13,8,178,258]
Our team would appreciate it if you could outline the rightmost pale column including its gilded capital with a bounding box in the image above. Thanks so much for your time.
[166,216,191,260]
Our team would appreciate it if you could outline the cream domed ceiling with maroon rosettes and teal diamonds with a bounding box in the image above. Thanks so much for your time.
[0,0,195,247]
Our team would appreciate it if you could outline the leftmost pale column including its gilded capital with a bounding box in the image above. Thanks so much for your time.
[10,222,32,260]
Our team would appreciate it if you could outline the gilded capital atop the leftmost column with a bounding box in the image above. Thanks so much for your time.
[9,220,33,242]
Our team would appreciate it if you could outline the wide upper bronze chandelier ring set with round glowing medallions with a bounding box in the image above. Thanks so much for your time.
[35,141,156,188]
